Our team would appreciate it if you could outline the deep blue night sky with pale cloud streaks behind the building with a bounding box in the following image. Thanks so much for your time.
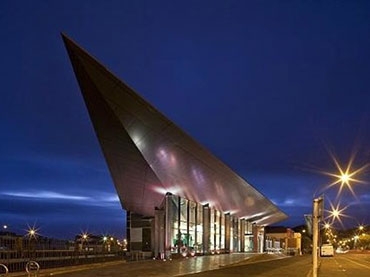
[0,0,370,238]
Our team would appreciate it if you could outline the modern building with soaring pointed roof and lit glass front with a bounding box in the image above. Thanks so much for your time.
[62,35,287,258]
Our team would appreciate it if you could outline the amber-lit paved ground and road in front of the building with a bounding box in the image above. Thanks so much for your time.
[5,251,370,277]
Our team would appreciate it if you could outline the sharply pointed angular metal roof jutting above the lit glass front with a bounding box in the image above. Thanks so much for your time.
[62,35,287,225]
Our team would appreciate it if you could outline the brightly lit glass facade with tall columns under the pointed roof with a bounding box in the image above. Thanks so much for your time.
[165,191,253,256]
